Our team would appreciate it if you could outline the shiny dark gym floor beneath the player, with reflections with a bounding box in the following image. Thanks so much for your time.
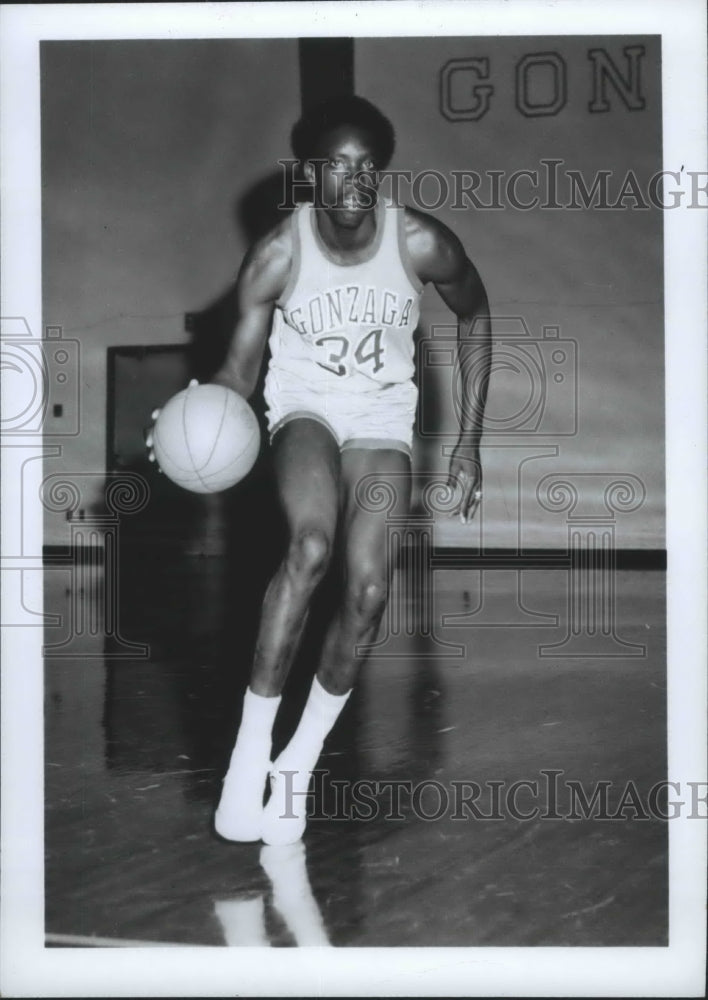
[46,557,668,947]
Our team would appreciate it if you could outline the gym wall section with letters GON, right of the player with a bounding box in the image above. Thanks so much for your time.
[355,36,668,548]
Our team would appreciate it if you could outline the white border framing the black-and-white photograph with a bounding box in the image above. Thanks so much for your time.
[0,0,706,996]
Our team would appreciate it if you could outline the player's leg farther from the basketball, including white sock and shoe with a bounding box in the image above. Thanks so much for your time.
[263,448,410,844]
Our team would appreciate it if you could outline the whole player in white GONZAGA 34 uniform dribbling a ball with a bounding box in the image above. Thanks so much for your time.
[202,97,491,844]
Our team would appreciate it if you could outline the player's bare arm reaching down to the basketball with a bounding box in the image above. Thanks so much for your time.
[212,226,292,399]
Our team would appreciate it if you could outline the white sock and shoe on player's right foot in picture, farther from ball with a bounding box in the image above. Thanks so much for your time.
[261,677,351,845]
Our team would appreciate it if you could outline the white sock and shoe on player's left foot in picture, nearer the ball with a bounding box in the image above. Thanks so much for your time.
[214,688,281,841]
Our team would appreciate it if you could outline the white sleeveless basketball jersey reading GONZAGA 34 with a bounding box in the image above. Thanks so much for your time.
[269,200,423,391]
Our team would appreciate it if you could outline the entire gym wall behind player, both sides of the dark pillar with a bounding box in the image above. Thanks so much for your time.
[41,36,664,549]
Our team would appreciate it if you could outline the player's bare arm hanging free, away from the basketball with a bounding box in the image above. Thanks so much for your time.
[408,210,492,521]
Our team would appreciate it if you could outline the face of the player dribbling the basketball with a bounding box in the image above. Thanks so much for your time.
[305,125,378,228]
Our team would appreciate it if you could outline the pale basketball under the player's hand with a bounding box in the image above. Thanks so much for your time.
[153,384,260,493]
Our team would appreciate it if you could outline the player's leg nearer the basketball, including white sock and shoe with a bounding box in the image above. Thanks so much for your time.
[214,419,340,840]
